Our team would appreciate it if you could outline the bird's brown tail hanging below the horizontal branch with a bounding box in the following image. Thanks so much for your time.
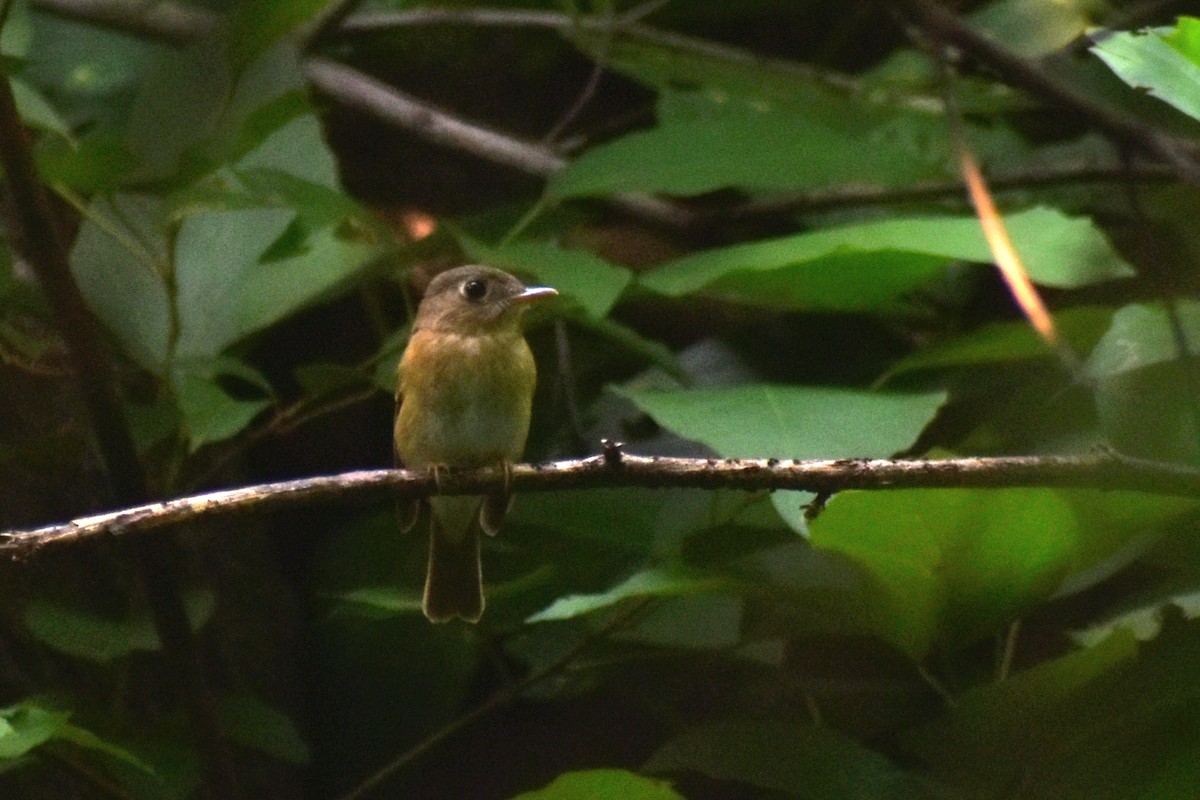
[422,498,484,622]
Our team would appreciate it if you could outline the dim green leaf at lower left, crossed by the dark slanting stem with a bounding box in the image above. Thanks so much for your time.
[25,591,216,663]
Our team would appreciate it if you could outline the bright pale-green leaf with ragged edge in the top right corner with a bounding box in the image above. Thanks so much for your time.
[1092,17,1200,120]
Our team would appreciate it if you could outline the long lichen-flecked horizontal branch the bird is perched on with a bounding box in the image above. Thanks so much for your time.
[0,447,1200,557]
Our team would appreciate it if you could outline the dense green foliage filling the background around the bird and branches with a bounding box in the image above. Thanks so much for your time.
[0,0,1200,800]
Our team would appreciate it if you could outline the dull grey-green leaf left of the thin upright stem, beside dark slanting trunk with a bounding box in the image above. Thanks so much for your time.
[71,194,172,375]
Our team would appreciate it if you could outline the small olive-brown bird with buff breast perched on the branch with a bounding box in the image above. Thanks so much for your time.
[395,265,558,622]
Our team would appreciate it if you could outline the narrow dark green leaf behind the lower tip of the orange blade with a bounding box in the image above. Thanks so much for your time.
[881,306,1112,381]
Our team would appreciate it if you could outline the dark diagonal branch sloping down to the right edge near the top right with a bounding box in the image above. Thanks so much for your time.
[896,0,1200,184]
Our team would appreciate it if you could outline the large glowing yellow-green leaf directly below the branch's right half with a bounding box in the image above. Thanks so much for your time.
[809,488,1195,657]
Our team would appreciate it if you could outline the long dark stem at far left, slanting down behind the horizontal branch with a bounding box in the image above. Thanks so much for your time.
[0,57,239,798]
